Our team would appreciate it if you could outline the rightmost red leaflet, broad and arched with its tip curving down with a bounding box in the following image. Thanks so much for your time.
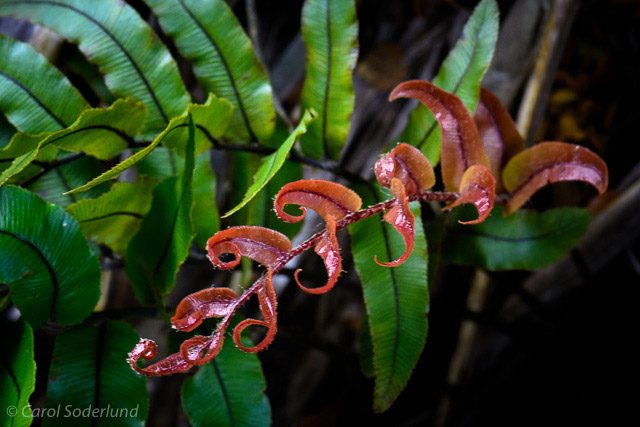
[502,142,609,214]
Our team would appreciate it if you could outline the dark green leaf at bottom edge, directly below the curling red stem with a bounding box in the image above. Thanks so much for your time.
[181,341,271,427]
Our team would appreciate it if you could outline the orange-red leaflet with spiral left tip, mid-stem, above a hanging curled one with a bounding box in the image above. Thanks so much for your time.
[274,179,362,222]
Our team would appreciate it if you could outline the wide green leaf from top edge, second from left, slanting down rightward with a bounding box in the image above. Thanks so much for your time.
[146,0,275,145]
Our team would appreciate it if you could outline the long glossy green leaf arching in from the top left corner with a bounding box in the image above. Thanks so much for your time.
[0,0,189,138]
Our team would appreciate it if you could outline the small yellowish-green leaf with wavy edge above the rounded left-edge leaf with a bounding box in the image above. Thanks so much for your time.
[67,179,155,254]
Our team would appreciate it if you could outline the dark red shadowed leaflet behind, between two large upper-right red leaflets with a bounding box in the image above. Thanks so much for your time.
[474,89,524,184]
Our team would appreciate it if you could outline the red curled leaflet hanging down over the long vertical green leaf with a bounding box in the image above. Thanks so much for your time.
[374,178,415,267]
